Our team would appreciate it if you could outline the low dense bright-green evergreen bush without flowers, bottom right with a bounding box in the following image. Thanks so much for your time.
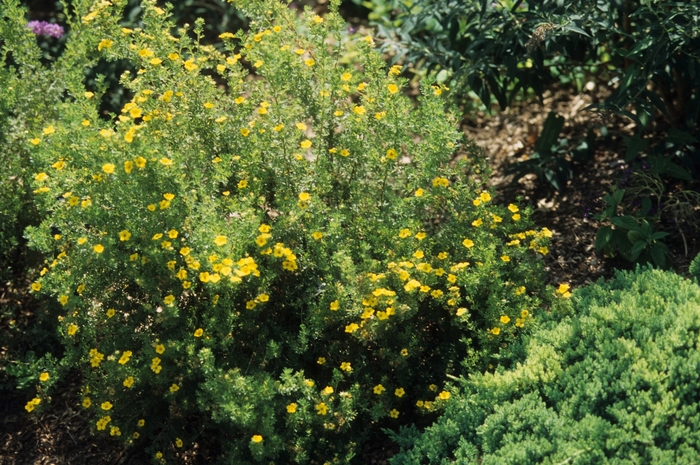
[391,269,700,465]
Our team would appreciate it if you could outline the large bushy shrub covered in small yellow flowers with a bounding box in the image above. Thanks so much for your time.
[8,0,552,463]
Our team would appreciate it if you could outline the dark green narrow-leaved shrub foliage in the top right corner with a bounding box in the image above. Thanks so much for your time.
[382,0,700,127]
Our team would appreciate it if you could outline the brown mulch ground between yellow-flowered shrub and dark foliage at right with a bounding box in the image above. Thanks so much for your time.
[462,84,700,288]
